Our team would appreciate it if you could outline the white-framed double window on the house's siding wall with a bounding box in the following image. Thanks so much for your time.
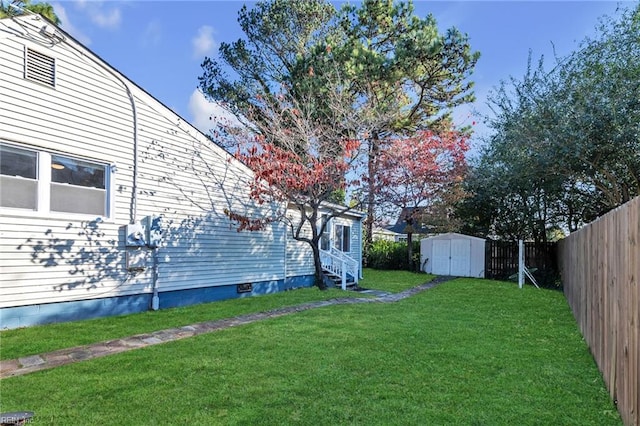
[0,143,111,217]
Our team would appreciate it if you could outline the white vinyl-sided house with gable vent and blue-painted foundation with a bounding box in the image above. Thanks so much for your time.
[0,16,361,328]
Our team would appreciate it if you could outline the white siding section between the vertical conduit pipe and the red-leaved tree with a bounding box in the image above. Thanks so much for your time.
[130,96,285,291]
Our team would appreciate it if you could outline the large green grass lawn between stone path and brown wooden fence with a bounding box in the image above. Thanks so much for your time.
[0,279,621,425]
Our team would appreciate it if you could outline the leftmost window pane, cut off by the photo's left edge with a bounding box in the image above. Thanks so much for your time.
[0,145,38,210]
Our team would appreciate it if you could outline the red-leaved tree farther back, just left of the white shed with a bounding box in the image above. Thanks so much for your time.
[376,130,469,265]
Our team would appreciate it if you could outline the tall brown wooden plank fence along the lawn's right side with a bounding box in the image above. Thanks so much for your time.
[558,197,640,425]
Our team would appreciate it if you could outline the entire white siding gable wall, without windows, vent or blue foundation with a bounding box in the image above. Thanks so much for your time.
[0,19,284,307]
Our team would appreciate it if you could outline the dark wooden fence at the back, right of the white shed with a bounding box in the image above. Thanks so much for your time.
[484,240,559,287]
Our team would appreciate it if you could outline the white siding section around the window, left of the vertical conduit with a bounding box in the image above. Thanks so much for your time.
[0,20,142,307]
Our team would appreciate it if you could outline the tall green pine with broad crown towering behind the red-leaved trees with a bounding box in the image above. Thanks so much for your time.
[199,0,479,256]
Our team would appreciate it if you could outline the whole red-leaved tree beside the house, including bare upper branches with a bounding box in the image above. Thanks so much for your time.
[218,64,364,288]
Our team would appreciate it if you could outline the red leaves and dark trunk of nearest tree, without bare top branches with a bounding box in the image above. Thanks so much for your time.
[227,137,359,288]
